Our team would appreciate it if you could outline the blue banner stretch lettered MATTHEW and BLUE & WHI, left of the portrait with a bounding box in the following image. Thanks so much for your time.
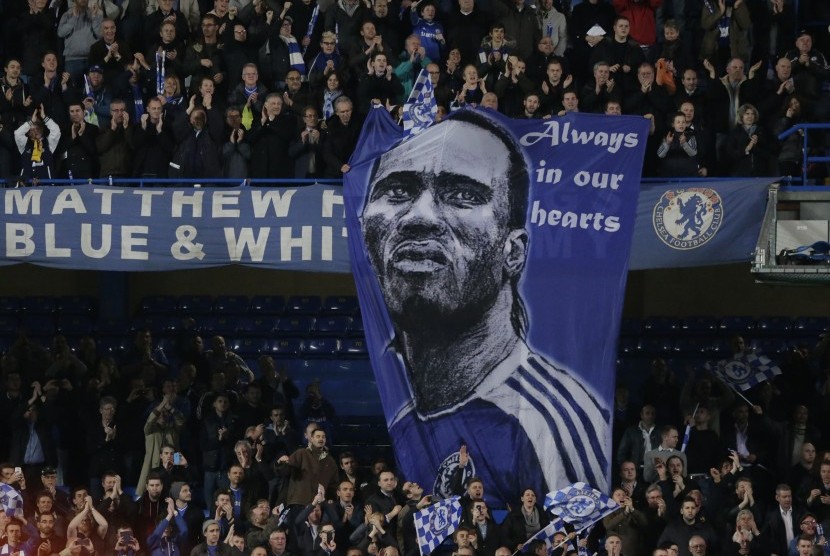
[0,185,349,272]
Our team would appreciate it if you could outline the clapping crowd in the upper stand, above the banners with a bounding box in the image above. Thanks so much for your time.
[0,0,830,183]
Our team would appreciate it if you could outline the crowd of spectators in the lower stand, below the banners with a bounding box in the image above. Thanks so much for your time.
[0,320,830,556]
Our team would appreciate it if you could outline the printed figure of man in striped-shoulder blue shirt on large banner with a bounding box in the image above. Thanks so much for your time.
[360,110,609,500]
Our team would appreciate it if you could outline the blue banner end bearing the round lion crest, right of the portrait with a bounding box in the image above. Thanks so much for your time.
[630,178,777,270]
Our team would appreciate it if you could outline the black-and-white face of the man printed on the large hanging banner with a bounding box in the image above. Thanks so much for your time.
[362,121,525,324]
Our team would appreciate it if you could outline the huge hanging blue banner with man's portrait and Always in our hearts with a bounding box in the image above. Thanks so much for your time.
[344,108,648,503]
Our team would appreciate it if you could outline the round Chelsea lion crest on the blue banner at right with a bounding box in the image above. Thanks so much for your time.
[652,187,723,250]
